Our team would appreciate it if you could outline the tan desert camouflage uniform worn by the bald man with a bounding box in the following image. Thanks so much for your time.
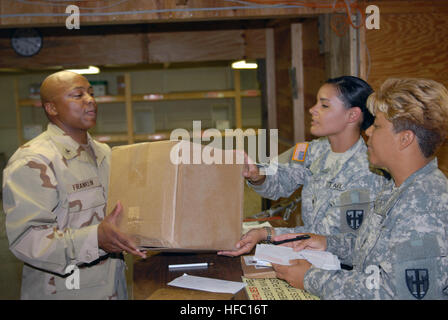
[3,123,127,299]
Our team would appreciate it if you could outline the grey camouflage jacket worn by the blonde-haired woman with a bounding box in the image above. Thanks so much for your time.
[304,159,448,299]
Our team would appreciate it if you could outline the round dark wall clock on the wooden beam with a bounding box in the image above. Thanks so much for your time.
[11,28,43,57]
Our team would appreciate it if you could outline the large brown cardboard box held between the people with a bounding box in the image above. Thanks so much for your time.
[107,141,244,251]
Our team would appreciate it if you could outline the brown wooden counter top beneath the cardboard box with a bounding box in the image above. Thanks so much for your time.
[133,252,248,300]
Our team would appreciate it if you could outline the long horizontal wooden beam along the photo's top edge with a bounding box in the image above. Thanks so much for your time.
[0,0,345,28]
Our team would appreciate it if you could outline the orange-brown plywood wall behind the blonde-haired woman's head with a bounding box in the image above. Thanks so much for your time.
[363,1,448,176]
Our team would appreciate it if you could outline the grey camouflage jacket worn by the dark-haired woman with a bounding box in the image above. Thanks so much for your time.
[248,137,383,235]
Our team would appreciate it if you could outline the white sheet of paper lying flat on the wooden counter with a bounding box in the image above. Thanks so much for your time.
[168,273,246,294]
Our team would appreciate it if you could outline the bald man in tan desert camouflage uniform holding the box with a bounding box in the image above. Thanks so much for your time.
[3,71,143,299]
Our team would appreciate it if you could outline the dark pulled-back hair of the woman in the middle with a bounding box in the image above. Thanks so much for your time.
[325,76,375,130]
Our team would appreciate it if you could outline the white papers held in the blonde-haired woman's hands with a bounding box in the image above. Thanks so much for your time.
[254,244,341,270]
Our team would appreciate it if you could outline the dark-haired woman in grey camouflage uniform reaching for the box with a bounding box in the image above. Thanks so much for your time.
[220,76,382,256]
